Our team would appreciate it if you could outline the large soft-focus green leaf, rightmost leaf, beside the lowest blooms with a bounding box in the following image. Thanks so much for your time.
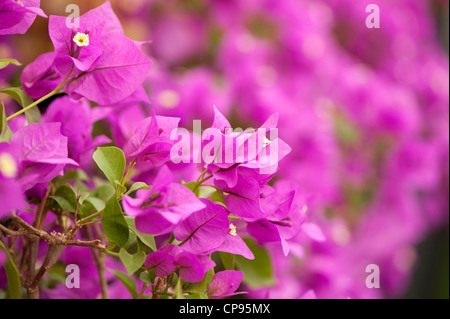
[235,239,275,289]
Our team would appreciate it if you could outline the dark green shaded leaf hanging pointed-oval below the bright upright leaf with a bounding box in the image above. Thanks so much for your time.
[102,196,129,247]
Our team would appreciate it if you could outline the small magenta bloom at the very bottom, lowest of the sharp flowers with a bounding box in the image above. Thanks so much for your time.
[206,270,246,299]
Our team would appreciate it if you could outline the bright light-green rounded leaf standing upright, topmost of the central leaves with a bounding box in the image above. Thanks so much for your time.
[93,146,126,189]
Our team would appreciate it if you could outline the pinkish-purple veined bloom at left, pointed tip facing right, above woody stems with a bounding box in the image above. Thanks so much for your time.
[10,123,78,190]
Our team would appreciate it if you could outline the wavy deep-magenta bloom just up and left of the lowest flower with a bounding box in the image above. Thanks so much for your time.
[144,244,215,282]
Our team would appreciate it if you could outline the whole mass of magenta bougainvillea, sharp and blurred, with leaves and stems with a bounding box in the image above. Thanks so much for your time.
[0,0,449,299]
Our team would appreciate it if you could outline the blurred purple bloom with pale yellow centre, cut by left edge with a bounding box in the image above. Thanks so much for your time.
[0,143,26,220]
